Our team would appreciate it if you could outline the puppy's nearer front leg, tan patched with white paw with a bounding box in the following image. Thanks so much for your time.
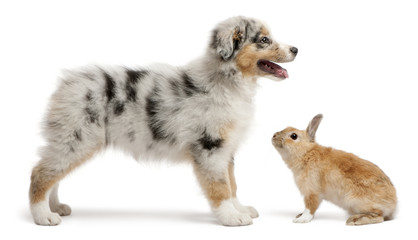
[194,154,253,226]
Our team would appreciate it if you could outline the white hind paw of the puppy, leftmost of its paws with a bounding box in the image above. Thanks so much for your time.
[31,201,61,226]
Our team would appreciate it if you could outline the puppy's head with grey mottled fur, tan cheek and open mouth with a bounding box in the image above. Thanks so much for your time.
[209,17,298,80]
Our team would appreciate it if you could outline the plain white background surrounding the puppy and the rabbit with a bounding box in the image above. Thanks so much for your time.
[0,0,418,239]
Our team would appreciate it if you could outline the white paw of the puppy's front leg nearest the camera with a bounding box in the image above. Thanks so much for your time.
[214,199,253,226]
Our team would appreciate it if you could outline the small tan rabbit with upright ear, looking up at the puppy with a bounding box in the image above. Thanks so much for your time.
[272,114,397,225]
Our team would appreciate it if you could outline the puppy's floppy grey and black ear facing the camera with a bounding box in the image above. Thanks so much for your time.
[211,26,245,61]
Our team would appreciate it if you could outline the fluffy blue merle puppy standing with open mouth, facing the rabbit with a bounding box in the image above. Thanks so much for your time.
[29,17,298,226]
